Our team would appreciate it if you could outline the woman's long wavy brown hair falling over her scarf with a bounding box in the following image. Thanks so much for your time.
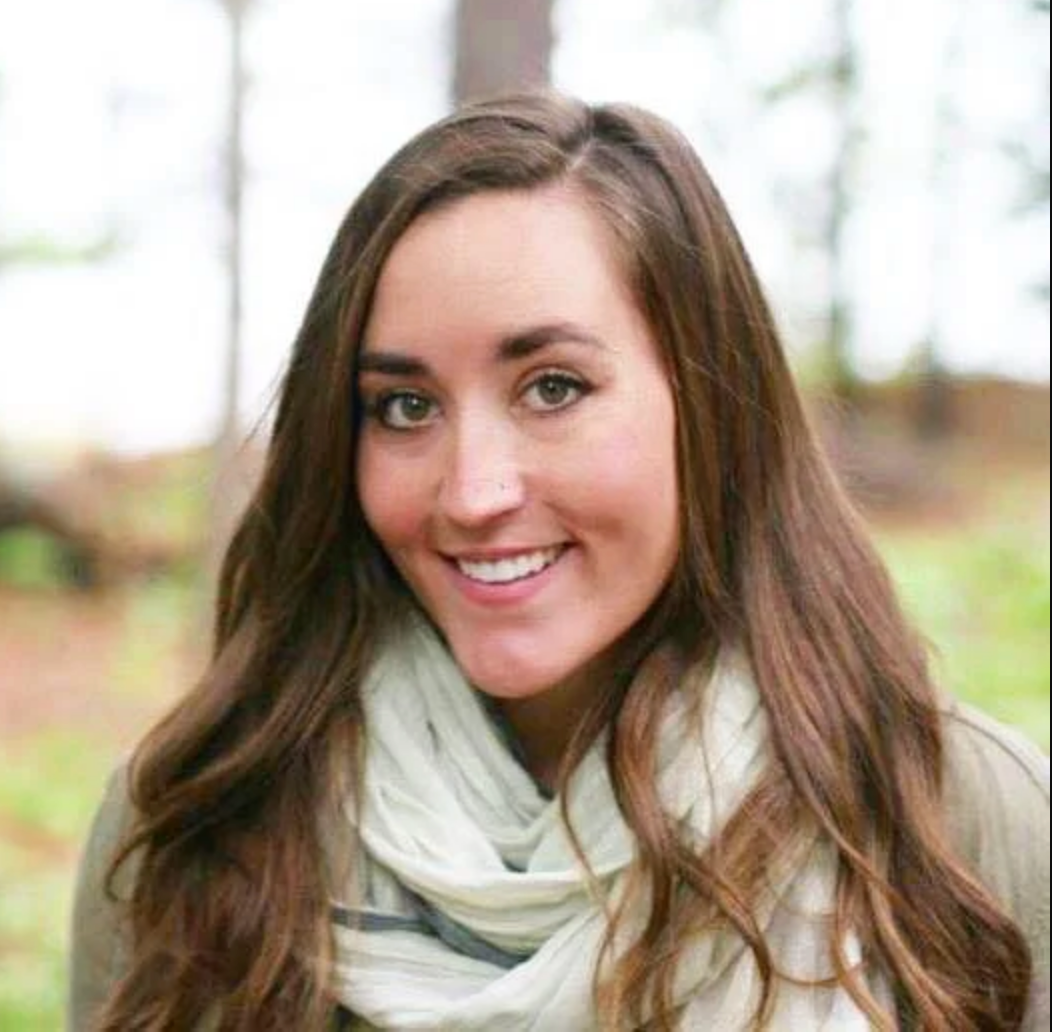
[101,95,1030,1032]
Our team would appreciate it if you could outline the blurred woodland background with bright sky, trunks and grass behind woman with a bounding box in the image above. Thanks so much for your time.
[0,0,1049,1032]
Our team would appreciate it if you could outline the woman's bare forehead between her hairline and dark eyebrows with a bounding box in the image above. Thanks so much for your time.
[365,184,638,346]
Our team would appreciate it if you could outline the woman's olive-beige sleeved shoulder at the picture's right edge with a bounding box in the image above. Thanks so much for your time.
[944,704,1049,1029]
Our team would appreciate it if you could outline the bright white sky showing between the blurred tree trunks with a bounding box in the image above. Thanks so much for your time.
[0,0,1049,451]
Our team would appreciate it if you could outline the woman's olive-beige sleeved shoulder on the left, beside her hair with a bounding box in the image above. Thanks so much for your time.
[67,765,134,1032]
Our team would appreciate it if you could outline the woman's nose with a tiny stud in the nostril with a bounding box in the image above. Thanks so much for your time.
[439,413,525,527]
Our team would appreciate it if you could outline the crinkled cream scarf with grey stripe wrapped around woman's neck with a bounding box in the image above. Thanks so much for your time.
[333,628,869,1032]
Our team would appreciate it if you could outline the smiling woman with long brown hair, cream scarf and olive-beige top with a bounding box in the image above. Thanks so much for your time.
[73,90,1049,1032]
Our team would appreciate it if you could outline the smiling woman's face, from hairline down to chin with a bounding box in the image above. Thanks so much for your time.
[358,186,679,700]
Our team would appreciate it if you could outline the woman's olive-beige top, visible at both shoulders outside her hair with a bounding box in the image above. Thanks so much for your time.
[67,707,1049,1032]
